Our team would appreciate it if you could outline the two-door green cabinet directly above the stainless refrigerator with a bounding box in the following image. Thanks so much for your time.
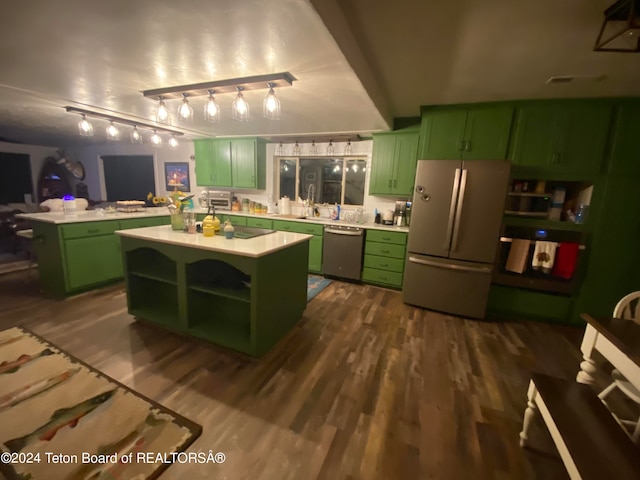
[420,105,513,160]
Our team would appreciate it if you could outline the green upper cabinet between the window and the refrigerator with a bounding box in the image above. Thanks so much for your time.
[369,129,420,195]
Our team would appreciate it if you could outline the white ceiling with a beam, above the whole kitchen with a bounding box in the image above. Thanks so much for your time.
[0,0,640,147]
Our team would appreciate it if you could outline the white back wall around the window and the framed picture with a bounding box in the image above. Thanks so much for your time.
[66,140,404,220]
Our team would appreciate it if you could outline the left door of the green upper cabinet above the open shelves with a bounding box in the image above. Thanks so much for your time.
[512,104,562,168]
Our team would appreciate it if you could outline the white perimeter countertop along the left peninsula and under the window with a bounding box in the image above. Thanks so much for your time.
[16,207,409,233]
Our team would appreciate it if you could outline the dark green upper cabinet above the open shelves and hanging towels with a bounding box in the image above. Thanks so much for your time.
[512,101,612,174]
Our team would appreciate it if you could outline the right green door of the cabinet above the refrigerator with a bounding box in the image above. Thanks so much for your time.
[462,106,513,160]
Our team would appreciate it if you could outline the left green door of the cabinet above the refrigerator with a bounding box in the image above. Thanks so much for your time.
[420,108,467,160]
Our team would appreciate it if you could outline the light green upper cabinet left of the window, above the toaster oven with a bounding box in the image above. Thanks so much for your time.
[194,138,267,190]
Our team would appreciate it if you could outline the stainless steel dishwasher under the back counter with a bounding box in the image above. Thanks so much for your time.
[322,225,364,280]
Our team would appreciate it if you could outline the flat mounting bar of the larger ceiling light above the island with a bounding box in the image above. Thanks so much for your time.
[142,72,296,99]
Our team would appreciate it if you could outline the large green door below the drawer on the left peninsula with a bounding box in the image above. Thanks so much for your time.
[64,235,122,290]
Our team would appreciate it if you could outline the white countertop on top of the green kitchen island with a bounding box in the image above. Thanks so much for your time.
[116,225,313,258]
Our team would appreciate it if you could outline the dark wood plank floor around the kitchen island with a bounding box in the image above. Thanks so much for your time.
[0,272,596,480]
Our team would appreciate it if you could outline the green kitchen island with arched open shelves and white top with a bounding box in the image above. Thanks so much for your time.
[115,226,312,357]
